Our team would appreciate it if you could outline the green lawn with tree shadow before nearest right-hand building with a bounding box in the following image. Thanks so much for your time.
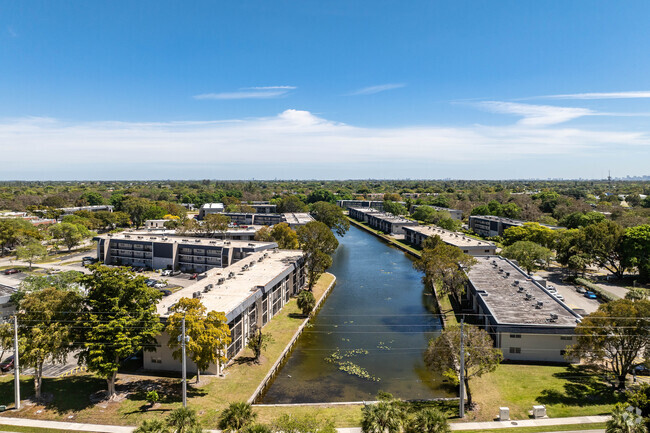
[470,364,619,421]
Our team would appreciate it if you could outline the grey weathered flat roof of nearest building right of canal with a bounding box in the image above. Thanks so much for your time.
[468,256,580,328]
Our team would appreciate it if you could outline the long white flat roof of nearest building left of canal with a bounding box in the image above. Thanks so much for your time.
[157,250,302,321]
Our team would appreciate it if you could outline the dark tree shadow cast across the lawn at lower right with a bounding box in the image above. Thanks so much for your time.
[537,365,622,407]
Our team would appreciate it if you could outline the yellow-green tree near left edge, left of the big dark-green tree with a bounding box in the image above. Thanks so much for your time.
[18,287,82,400]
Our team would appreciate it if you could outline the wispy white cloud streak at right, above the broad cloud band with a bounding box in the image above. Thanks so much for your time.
[478,101,599,126]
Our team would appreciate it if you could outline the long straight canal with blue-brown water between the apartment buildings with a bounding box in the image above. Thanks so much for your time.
[260,226,455,403]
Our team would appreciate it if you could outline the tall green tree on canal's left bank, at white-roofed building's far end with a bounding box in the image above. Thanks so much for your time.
[297,221,339,290]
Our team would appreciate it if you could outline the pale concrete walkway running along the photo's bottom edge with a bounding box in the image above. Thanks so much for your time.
[0,415,609,433]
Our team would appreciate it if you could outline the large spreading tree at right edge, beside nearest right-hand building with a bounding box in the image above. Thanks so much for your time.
[567,299,650,388]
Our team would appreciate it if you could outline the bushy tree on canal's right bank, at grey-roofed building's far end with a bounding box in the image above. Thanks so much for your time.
[413,235,476,296]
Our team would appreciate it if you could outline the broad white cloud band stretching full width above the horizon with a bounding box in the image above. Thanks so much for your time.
[0,110,650,178]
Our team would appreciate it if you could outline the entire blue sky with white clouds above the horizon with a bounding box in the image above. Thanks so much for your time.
[0,0,650,180]
